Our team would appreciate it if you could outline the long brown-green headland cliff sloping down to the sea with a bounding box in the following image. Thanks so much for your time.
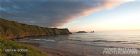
[0,18,71,39]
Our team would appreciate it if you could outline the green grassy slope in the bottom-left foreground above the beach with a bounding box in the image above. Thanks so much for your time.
[0,40,47,56]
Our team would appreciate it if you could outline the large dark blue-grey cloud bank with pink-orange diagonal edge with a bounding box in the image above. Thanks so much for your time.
[0,0,132,27]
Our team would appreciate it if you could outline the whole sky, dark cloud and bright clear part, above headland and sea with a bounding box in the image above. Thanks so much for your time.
[0,0,140,32]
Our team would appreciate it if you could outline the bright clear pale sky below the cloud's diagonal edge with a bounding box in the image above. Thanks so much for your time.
[63,0,140,32]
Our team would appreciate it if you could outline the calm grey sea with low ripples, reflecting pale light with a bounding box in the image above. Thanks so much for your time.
[19,31,140,56]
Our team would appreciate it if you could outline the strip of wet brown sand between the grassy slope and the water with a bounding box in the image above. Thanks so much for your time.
[19,42,81,56]
